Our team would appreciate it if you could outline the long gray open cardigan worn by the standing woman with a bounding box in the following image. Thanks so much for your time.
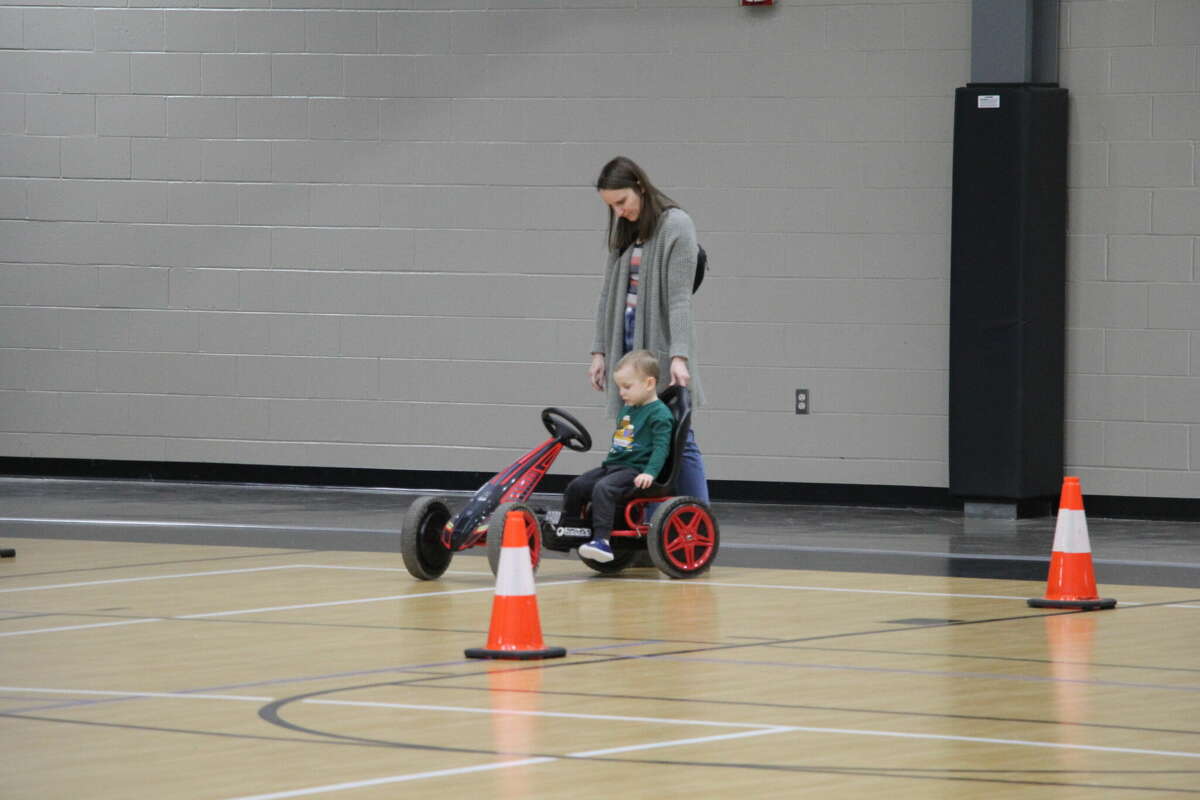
[592,209,704,417]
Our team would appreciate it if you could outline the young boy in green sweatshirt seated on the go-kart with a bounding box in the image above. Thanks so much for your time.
[563,350,674,563]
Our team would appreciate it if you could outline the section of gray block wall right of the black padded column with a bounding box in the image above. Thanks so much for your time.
[1060,0,1200,498]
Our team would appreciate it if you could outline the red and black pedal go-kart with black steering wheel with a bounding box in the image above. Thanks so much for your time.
[400,386,720,581]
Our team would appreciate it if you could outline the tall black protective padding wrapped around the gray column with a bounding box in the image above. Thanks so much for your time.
[949,84,1067,501]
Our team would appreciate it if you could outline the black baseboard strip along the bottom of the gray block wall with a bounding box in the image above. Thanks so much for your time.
[0,456,1200,521]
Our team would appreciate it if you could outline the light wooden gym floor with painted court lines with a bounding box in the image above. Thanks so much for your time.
[0,479,1200,800]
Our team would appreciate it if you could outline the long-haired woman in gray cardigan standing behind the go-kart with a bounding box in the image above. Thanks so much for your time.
[588,156,708,503]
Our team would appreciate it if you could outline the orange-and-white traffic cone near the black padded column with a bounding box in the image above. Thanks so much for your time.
[1027,477,1117,610]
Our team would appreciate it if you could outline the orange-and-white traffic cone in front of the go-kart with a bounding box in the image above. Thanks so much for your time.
[464,511,566,660]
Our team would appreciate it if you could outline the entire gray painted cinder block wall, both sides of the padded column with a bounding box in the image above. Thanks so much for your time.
[0,0,1200,497]
